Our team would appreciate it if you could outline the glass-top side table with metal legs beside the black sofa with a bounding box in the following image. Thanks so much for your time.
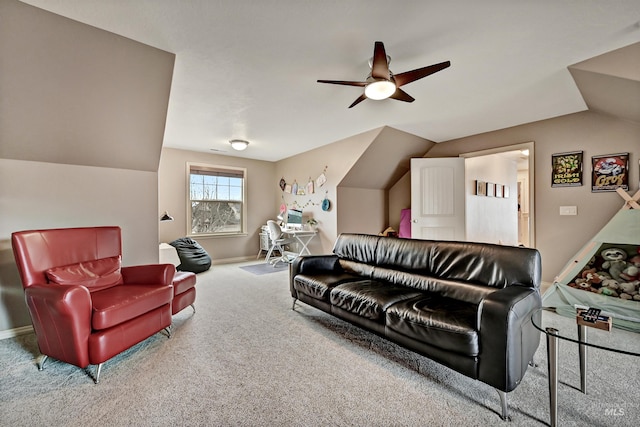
[531,309,640,427]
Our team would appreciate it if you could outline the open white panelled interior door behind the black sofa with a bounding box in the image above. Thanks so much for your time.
[411,157,466,241]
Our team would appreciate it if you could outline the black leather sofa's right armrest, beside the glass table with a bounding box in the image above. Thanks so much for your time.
[478,286,542,392]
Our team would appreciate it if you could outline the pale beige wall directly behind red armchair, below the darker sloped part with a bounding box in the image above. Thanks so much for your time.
[0,159,158,332]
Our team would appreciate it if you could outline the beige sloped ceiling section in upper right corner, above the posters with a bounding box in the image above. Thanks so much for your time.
[569,42,640,123]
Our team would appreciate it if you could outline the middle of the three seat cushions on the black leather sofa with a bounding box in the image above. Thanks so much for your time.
[329,280,420,322]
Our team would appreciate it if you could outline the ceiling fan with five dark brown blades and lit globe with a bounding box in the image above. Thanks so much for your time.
[318,42,451,108]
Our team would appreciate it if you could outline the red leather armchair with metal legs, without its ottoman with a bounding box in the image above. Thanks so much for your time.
[11,227,175,383]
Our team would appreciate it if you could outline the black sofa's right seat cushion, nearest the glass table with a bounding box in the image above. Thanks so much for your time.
[386,294,480,357]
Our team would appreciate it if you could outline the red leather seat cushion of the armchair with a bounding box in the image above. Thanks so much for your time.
[91,284,173,330]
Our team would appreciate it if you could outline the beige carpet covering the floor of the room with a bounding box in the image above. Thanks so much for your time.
[0,261,640,427]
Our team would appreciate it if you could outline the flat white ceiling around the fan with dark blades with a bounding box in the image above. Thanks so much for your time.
[20,0,640,161]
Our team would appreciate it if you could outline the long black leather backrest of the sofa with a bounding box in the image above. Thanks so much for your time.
[334,234,542,289]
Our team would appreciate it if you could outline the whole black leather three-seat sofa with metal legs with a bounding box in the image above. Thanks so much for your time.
[290,234,541,419]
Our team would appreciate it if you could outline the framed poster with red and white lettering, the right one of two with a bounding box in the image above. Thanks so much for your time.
[591,153,629,193]
